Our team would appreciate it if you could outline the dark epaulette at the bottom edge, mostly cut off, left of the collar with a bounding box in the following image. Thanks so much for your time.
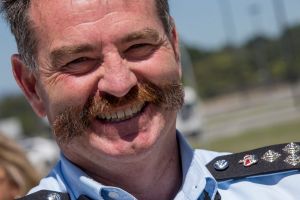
[16,190,90,200]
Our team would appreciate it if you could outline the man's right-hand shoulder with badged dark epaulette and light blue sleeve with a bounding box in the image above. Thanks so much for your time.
[206,143,300,200]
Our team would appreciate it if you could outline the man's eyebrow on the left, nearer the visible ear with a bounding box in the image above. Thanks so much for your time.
[50,44,96,67]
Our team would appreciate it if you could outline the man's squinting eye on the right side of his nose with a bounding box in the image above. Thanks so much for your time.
[124,43,157,61]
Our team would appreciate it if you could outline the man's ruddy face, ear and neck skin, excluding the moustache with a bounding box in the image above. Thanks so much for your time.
[12,0,182,200]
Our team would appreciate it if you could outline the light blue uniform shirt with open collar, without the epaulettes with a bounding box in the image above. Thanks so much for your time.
[30,134,300,200]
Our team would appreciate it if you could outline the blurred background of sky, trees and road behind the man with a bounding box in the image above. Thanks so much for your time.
[0,0,300,180]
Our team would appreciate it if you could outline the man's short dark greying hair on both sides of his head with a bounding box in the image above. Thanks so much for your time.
[0,0,173,70]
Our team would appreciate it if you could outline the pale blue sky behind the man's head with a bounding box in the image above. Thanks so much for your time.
[0,0,300,98]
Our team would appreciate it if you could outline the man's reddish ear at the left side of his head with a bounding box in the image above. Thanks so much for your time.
[11,54,46,117]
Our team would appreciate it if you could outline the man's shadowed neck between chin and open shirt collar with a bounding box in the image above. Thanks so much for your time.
[85,132,182,200]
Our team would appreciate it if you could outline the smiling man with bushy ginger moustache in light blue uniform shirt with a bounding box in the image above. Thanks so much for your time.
[2,0,300,200]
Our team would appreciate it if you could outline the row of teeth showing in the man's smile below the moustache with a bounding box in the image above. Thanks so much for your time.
[97,103,144,122]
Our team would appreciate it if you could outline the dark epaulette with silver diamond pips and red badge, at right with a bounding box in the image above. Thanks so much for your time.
[206,142,300,181]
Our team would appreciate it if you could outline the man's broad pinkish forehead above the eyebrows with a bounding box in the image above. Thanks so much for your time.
[29,0,162,53]
